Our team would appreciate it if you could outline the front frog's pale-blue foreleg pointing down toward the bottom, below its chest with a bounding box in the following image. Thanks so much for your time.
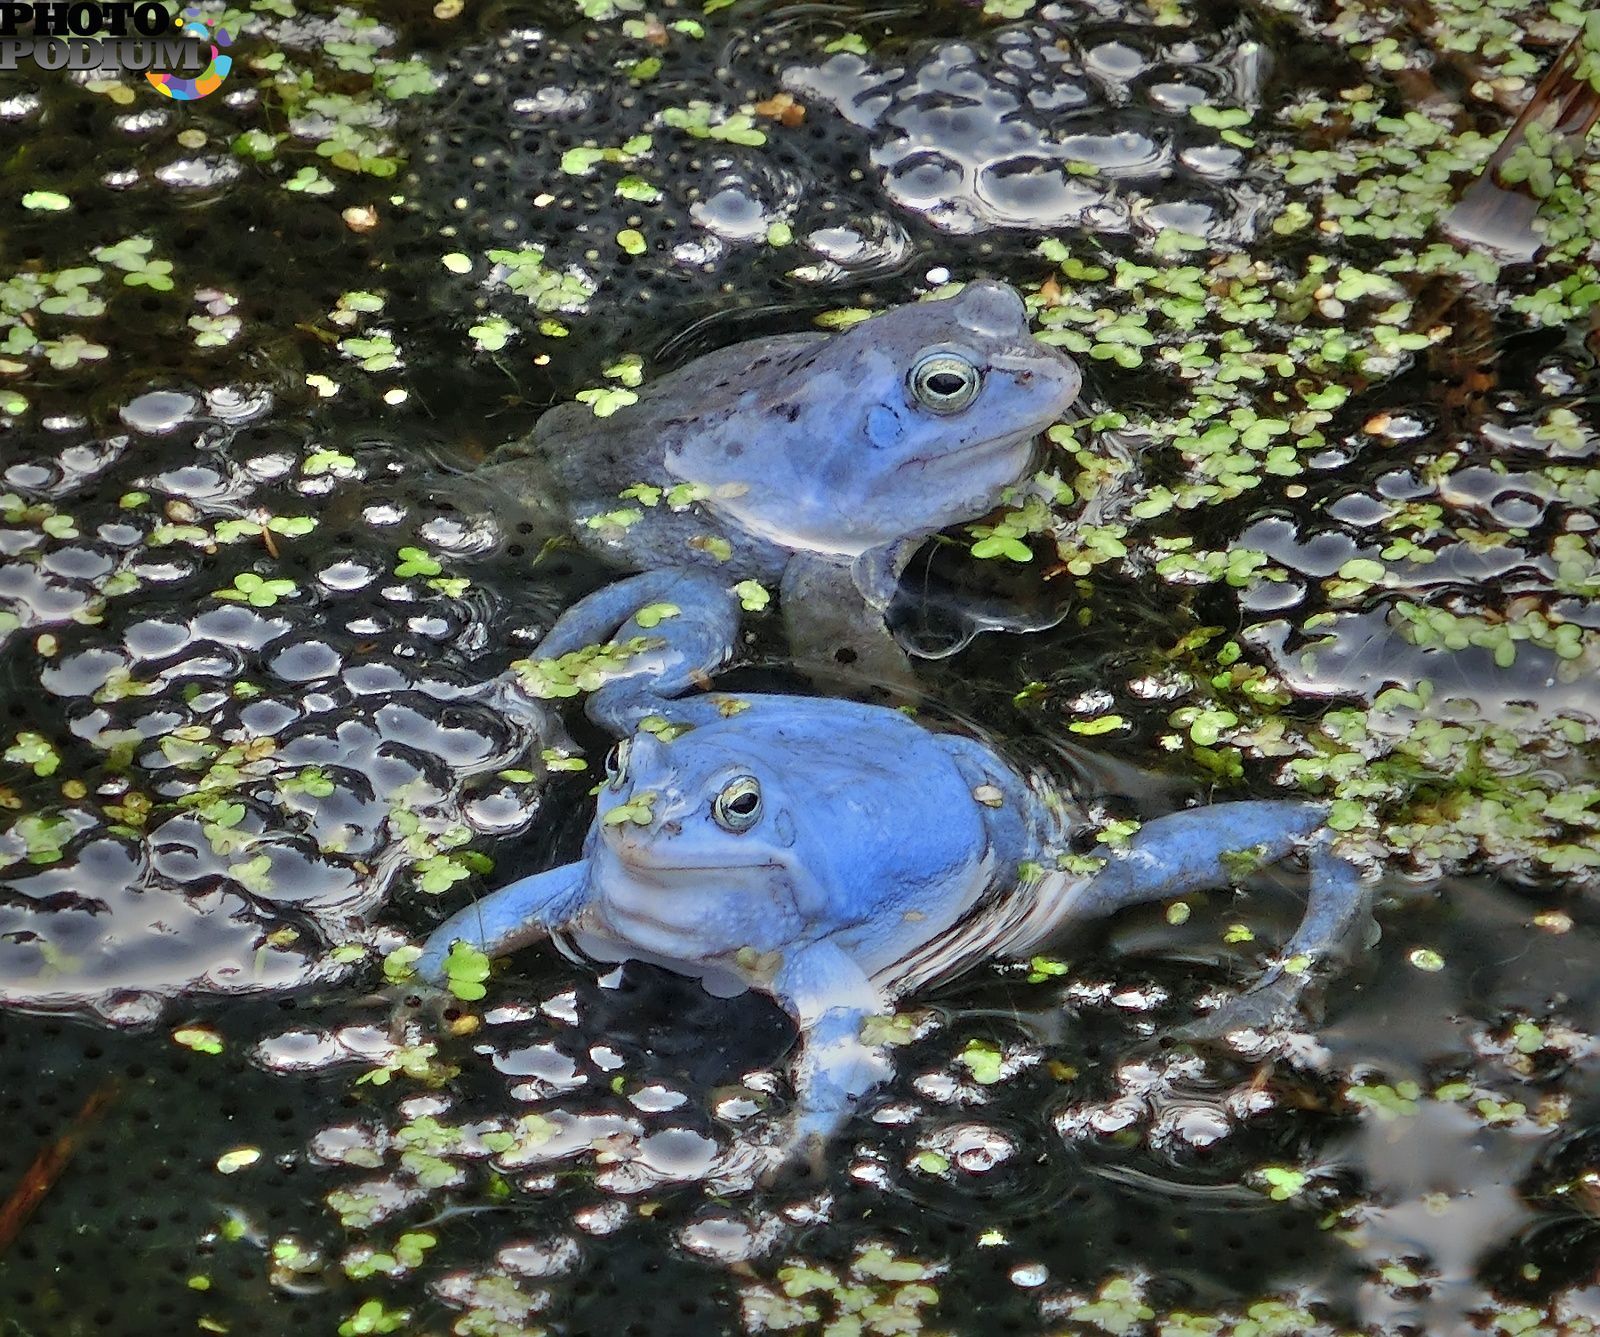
[773,942,893,1158]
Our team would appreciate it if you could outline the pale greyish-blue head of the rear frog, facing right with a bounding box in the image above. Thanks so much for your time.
[669,281,1082,557]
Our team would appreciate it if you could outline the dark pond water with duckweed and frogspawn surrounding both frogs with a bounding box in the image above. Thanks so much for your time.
[0,0,1600,1337]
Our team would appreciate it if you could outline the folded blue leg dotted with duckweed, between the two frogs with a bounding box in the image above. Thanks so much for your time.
[531,568,739,736]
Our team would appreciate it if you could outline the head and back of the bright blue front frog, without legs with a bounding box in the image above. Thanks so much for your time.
[589,697,986,972]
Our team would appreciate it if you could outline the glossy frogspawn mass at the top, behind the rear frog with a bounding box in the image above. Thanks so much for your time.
[408,5,1266,355]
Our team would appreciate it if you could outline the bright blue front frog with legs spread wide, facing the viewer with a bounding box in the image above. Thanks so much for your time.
[418,601,1366,1150]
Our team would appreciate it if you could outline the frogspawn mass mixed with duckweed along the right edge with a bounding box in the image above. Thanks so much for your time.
[1190,323,1600,891]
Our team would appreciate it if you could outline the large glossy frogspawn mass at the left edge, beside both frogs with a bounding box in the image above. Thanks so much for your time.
[0,392,547,1024]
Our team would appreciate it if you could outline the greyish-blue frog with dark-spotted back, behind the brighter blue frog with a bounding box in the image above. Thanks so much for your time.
[482,281,1082,678]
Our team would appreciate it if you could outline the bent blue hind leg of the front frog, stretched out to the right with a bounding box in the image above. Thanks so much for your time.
[1011,800,1371,1035]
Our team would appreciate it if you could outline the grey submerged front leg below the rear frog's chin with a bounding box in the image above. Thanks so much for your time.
[778,553,917,688]
